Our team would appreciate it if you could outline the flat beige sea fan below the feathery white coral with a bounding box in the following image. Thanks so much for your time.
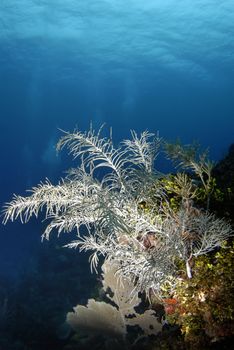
[67,261,162,349]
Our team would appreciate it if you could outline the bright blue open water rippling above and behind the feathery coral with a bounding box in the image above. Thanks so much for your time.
[0,0,234,274]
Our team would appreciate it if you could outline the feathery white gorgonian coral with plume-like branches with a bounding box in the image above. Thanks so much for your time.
[3,127,232,294]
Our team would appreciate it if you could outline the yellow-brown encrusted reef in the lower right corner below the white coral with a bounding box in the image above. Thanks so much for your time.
[166,243,234,349]
